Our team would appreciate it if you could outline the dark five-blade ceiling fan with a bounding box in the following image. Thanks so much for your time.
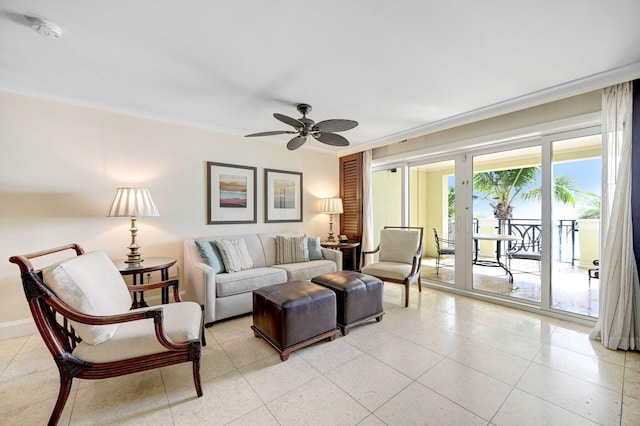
[245,104,358,151]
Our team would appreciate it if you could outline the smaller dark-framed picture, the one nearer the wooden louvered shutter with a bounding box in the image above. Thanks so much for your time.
[264,169,302,223]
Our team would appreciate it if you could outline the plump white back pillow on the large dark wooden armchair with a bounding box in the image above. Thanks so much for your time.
[42,251,131,345]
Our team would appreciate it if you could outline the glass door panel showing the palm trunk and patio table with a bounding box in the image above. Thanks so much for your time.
[471,145,542,303]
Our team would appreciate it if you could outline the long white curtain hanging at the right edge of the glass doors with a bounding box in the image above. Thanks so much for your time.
[590,82,640,350]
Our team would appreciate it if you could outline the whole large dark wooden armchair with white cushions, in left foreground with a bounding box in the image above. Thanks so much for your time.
[9,244,205,425]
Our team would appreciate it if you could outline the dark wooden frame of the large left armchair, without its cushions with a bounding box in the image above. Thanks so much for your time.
[9,244,206,425]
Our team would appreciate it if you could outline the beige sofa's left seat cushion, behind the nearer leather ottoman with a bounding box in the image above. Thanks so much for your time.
[216,268,287,297]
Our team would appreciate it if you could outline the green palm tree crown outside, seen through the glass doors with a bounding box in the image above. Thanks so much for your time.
[473,167,579,219]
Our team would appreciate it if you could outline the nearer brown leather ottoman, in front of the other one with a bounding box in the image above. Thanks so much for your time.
[251,281,338,361]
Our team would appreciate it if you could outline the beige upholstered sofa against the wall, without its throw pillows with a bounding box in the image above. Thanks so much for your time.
[184,232,342,326]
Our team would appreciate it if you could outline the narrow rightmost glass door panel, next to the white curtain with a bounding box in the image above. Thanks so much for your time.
[550,133,602,318]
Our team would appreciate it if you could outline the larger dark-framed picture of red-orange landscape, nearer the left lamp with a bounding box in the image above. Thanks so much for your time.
[207,161,257,225]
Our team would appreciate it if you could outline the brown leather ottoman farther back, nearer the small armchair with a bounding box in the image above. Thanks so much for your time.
[311,271,384,336]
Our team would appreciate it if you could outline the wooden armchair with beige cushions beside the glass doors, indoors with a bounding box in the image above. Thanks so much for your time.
[361,226,424,307]
